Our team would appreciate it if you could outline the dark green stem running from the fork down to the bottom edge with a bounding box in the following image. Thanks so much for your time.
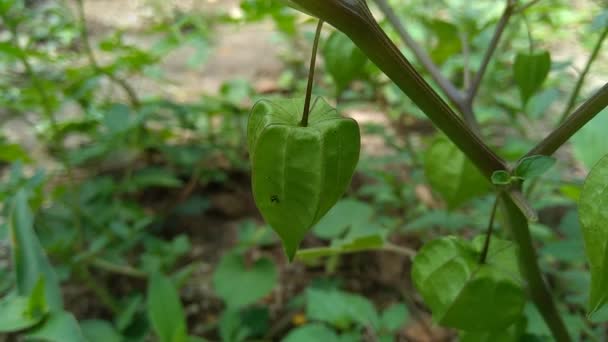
[501,194,571,342]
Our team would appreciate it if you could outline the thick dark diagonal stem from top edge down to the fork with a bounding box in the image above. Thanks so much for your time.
[291,0,507,179]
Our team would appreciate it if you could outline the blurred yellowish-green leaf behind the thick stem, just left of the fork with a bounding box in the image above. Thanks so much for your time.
[424,136,490,208]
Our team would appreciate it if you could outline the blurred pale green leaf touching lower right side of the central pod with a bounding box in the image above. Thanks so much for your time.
[313,199,374,240]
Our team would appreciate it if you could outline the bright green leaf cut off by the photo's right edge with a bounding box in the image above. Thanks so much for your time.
[578,155,608,314]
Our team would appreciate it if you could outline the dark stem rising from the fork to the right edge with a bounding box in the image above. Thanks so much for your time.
[522,83,608,159]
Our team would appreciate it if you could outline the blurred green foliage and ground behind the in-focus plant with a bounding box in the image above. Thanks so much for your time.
[0,0,608,342]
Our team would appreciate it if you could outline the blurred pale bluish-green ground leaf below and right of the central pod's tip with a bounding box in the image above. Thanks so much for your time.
[306,288,380,329]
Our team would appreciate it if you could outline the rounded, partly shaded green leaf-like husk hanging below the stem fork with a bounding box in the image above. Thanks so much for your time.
[412,237,526,331]
